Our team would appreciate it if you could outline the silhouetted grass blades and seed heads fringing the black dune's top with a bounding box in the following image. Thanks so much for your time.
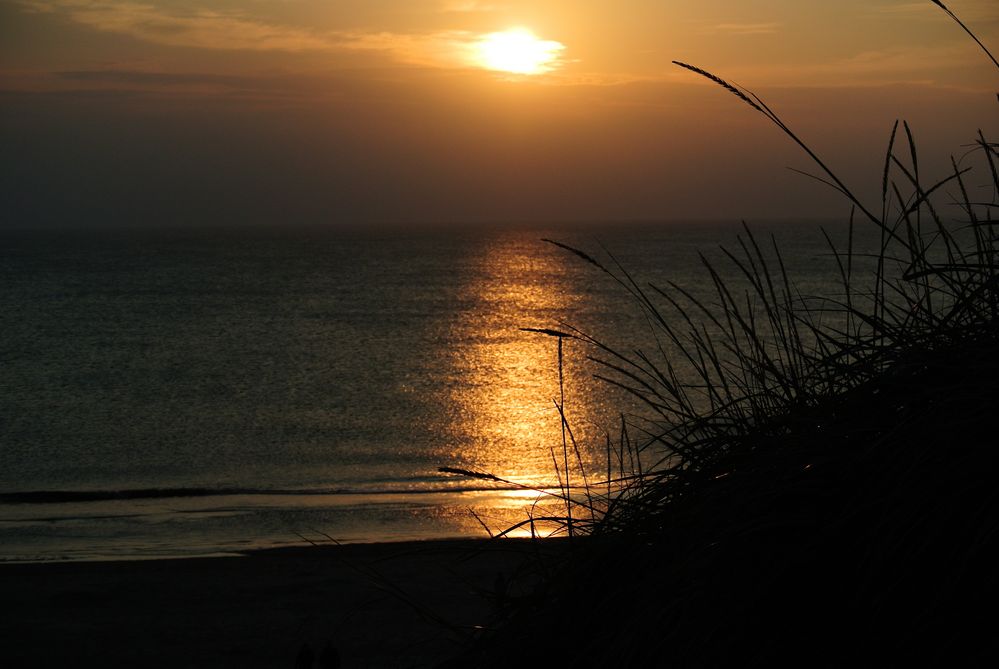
[452,1,999,552]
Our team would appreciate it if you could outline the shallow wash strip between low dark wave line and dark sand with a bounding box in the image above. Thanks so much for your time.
[0,489,564,565]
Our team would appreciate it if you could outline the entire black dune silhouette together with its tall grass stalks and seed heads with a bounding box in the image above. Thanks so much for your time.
[446,0,999,667]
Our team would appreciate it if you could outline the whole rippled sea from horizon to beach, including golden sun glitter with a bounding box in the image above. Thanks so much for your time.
[0,223,872,561]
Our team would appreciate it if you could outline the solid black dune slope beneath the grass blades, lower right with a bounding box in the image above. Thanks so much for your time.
[449,330,999,667]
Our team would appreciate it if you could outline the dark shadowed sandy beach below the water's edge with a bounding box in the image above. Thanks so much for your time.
[0,539,559,668]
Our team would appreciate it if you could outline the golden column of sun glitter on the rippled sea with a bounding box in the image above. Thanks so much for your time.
[449,236,612,503]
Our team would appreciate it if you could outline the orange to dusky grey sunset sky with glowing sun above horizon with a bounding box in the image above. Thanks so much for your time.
[0,0,999,226]
